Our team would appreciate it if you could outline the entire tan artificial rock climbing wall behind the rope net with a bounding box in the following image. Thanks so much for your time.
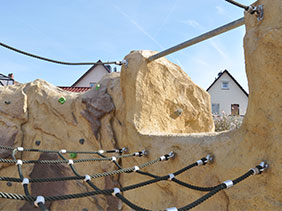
[0,0,282,210]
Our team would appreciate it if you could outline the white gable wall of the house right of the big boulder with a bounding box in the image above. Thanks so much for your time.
[208,73,248,115]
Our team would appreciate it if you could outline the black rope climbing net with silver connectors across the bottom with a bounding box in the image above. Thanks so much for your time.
[0,145,268,210]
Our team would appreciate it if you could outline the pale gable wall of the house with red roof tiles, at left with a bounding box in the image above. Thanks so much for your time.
[75,65,108,87]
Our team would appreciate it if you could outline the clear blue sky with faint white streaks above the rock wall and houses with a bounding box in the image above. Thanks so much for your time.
[0,0,254,91]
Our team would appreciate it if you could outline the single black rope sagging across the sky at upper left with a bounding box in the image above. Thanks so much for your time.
[0,42,122,65]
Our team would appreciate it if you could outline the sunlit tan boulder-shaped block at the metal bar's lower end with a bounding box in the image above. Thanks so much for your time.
[121,51,214,133]
